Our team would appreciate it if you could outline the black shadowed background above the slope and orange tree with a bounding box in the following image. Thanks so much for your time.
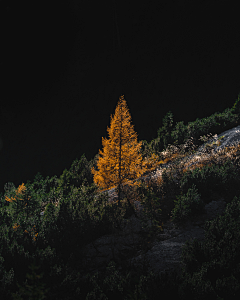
[0,0,240,196]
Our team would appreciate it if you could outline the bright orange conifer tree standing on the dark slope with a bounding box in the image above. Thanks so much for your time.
[92,95,144,205]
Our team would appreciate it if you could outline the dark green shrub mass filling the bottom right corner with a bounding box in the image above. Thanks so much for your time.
[181,197,240,299]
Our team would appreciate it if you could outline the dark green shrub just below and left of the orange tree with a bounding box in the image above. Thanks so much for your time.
[55,180,120,258]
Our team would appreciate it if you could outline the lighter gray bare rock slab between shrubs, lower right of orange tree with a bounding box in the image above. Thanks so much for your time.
[127,199,226,274]
